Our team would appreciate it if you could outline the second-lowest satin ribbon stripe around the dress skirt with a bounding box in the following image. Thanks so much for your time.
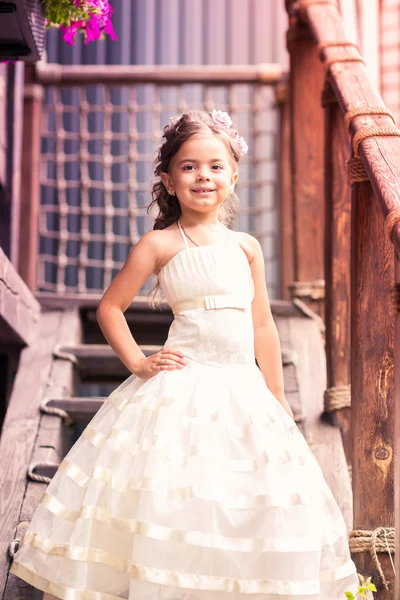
[36,495,345,553]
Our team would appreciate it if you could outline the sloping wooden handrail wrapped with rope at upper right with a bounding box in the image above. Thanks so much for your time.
[299,2,400,252]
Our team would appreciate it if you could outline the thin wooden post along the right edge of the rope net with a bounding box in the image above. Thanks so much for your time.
[275,80,294,300]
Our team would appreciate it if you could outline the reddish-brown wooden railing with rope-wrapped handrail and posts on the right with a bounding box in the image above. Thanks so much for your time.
[281,0,400,600]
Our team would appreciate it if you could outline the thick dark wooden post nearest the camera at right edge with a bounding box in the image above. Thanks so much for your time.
[351,176,395,600]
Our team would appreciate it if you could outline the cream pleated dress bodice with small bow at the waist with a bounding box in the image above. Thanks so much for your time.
[159,221,254,365]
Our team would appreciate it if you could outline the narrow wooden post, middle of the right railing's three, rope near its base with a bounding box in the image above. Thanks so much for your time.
[322,86,352,467]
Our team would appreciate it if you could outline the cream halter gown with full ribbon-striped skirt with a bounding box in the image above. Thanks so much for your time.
[11,221,358,600]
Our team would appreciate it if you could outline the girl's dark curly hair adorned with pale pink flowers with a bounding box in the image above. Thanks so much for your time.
[147,110,241,229]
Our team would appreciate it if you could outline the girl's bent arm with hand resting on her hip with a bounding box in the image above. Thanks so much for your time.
[96,231,184,377]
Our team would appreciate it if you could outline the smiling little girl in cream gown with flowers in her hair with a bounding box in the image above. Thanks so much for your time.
[11,111,358,600]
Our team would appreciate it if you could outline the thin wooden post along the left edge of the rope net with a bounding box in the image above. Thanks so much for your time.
[18,65,43,291]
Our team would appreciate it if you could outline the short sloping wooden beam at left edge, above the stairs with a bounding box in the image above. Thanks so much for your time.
[0,248,40,345]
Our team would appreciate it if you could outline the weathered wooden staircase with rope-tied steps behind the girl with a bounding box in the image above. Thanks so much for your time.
[0,300,352,600]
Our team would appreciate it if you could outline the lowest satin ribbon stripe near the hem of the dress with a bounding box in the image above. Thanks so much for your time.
[12,534,355,594]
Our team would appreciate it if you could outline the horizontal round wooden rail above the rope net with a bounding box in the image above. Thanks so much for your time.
[36,62,283,86]
